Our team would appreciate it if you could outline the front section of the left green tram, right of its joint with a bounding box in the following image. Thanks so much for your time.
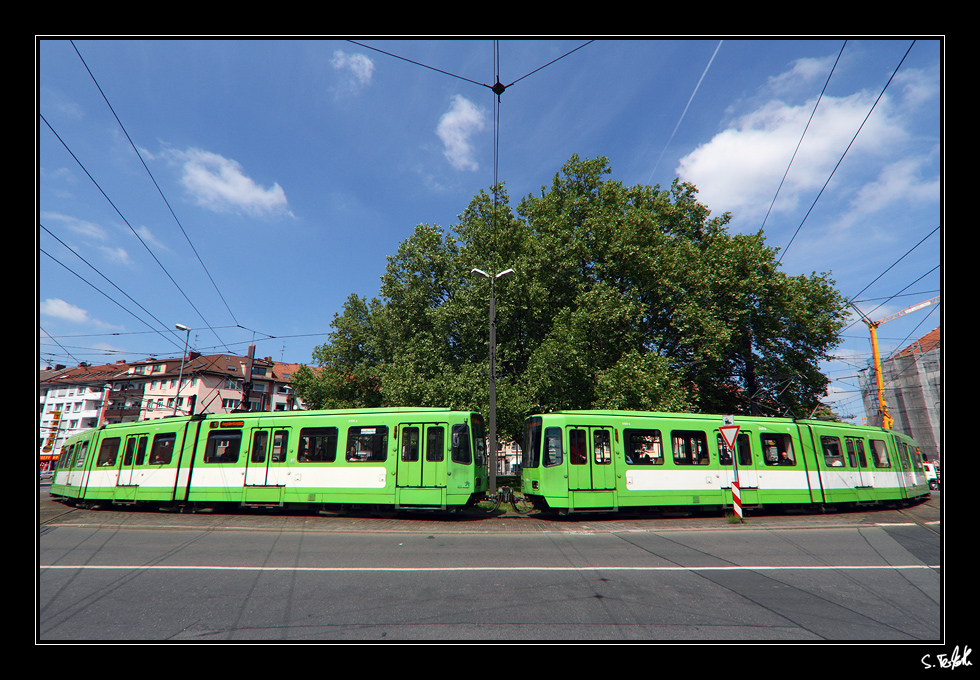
[185,412,486,506]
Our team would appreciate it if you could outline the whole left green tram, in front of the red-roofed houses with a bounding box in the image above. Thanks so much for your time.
[51,408,487,510]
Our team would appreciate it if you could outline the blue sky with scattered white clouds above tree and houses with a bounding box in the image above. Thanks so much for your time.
[35,37,944,418]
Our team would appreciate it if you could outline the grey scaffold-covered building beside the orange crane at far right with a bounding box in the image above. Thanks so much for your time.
[860,327,943,460]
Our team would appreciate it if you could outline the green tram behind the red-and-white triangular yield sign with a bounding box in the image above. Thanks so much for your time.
[521,411,929,514]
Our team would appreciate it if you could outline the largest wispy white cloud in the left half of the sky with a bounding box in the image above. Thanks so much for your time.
[167,148,290,215]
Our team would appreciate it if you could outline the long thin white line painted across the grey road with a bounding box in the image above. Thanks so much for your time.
[39,564,942,573]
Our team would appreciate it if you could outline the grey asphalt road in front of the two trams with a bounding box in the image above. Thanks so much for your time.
[37,492,948,652]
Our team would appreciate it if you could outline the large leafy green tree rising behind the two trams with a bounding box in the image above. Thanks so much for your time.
[296,156,844,438]
